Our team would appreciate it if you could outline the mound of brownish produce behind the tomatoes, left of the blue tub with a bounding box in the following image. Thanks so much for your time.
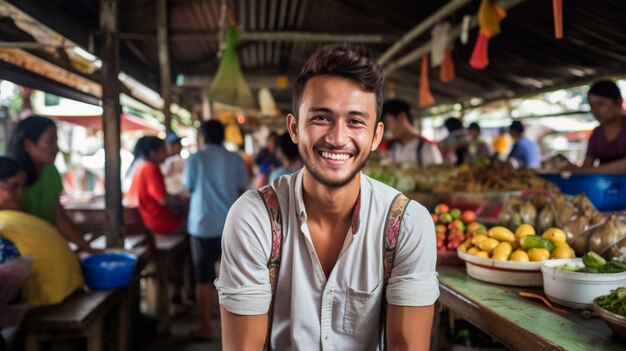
[434,163,556,193]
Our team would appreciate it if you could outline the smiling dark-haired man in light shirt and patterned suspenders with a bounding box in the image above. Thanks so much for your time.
[216,45,439,350]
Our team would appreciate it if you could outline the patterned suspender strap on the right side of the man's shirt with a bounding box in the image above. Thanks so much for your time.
[380,193,409,350]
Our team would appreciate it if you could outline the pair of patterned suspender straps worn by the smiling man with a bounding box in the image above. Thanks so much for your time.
[258,185,409,351]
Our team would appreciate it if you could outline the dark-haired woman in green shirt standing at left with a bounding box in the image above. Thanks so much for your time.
[7,116,95,252]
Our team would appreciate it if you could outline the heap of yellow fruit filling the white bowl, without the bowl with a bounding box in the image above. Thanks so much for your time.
[459,224,574,262]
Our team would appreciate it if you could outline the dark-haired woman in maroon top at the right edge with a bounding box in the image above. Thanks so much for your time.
[563,80,626,174]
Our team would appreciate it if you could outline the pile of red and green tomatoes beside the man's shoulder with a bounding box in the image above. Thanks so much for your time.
[432,204,487,251]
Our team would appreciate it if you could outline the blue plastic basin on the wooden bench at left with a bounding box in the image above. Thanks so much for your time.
[81,252,137,290]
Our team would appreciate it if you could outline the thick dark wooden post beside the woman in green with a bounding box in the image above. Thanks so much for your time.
[100,0,123,247]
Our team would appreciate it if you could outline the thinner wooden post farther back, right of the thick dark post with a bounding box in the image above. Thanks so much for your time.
[157,0,172,133]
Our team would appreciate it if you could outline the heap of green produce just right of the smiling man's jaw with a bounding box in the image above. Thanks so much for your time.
[363,161,460,192]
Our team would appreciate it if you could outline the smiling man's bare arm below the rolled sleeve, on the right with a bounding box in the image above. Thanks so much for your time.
[385,305,435,351]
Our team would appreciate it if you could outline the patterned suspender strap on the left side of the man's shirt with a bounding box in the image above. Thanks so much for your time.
[258,185,283,350]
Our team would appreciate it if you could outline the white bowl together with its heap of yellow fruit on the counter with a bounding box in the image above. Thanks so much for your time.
[457,224,574,286]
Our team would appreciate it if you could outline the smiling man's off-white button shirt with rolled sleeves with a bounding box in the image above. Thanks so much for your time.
[215,171,439,350]
